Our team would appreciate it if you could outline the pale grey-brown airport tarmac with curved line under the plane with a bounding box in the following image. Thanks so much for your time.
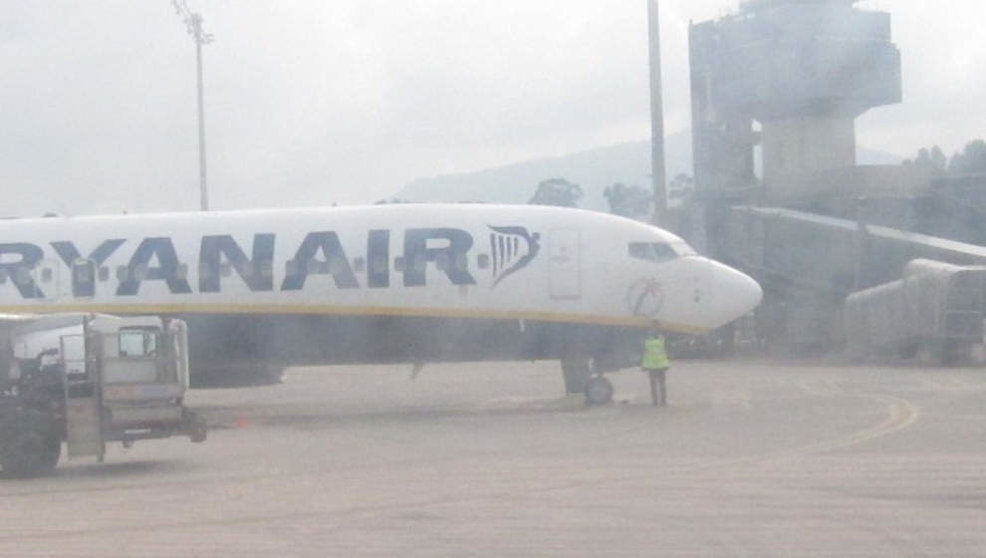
[0,361,986,557]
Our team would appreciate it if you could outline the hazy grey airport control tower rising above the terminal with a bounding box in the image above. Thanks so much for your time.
[690,0,901,205]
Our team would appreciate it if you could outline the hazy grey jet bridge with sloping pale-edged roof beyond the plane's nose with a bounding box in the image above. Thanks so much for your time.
[714,206,986,349]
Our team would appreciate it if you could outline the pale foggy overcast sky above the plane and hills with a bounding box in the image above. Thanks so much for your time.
[0,0,986,215]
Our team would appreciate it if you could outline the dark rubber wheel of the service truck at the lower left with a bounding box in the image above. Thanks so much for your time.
[0,412,62,478]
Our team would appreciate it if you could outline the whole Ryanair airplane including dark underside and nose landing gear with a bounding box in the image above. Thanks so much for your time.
[0,204,762,399]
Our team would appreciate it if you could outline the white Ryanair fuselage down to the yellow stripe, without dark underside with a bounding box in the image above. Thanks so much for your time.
[0,204,761,335]
